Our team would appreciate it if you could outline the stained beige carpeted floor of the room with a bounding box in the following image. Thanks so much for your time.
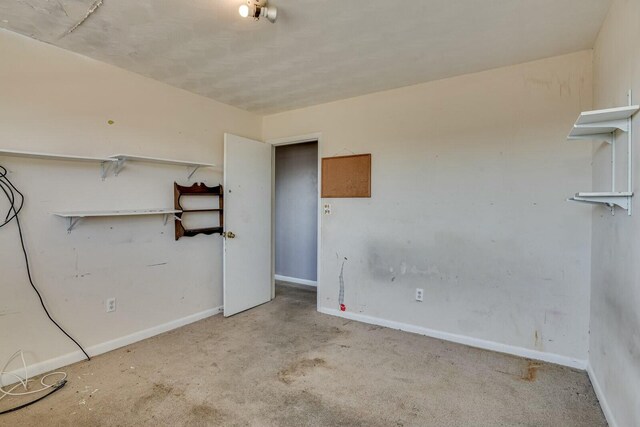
[0,284,606,427]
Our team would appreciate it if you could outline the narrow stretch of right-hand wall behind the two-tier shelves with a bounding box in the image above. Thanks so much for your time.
[584,0,640,427]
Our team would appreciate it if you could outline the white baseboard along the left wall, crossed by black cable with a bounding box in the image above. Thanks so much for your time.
[3,306,223,385]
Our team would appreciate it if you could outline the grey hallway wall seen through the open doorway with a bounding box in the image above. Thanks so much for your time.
[274,142,318,282]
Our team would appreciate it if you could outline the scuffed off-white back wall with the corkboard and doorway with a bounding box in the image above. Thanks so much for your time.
[263,51,592,366]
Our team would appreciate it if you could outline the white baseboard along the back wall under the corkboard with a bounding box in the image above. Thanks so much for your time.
[318,307,587,370]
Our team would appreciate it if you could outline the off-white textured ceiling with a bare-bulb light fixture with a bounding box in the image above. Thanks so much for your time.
[0,0,610,114]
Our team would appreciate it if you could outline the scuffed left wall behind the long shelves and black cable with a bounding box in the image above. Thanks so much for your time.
[0,30,261,376]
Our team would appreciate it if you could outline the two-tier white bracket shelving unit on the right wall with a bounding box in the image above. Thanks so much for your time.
[567,91,640,215]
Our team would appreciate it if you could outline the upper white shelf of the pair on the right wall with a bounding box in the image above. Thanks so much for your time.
[568,105,640,142]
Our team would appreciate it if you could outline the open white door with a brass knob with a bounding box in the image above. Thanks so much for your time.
[223,133,273,317]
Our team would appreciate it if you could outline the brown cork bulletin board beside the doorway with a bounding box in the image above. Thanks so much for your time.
[322,154,371,198]
